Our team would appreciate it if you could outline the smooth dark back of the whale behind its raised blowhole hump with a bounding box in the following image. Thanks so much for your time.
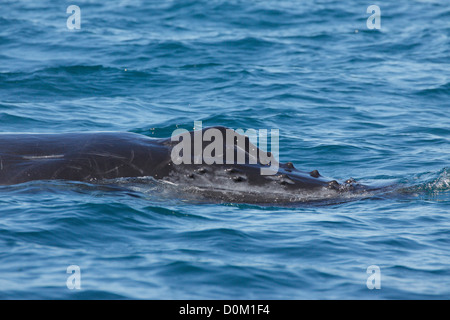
[0,132,168,185]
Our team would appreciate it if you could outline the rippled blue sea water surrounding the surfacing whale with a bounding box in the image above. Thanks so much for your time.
[0,0,450,299]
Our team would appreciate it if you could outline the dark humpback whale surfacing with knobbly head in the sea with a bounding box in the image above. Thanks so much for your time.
[0,127,368,203]
